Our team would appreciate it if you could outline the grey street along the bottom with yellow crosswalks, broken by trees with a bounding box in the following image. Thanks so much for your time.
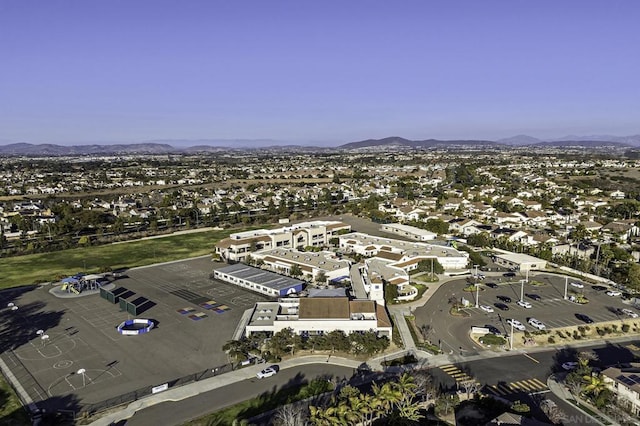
[121,341,640,426]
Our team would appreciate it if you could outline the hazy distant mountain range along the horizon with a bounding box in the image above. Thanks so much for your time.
[0,135,640,156]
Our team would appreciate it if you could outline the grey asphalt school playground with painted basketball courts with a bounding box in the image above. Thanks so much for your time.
[0,257,266,411]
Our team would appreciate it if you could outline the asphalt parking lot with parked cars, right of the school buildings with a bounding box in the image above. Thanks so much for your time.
[415,272,640,355]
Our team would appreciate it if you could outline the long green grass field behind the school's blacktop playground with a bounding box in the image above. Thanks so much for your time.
[0,230,237,289]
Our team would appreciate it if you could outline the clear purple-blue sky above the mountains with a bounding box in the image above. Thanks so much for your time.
[0,0,640,144]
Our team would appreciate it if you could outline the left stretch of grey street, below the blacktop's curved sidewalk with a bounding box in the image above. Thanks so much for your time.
[126,364,354,426]
